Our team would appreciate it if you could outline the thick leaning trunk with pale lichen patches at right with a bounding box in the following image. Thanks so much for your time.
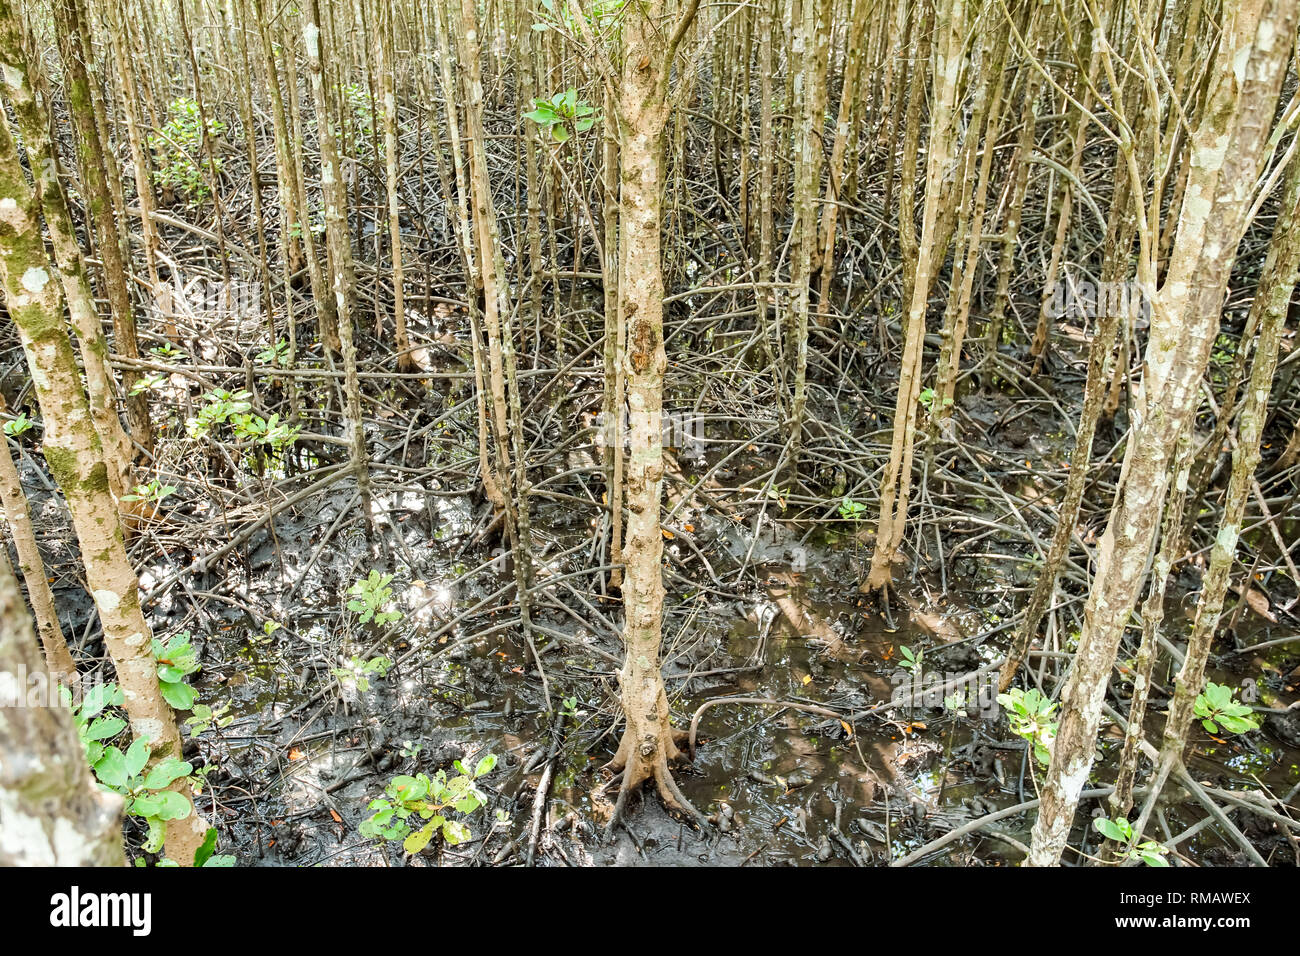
[1027,0,1296,866]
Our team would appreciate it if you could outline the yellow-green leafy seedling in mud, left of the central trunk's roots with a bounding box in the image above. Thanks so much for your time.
[360,753,497,853]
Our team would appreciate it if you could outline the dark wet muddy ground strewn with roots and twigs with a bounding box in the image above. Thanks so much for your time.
[10,299,1300,866]
